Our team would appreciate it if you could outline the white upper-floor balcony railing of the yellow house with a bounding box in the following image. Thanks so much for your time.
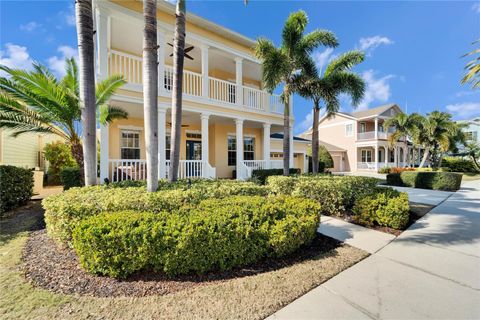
[108,50,284,114]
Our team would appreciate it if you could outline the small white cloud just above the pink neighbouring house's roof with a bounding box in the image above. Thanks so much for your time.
[358,70,395,110]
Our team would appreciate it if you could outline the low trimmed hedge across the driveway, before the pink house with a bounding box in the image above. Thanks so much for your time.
[387,171,463,191]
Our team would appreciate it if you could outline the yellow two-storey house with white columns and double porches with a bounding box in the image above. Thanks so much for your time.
[94,0,308,181]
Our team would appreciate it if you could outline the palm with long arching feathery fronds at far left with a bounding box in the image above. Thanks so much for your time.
[0,58,128,168]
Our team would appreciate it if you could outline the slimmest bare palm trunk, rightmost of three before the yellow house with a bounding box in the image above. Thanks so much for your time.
[169,0,186,182]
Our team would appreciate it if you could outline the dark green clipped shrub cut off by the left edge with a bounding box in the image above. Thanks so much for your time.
[0,165,33,216]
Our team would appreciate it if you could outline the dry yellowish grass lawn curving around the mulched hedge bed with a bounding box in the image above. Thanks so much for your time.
[0,202,368,319]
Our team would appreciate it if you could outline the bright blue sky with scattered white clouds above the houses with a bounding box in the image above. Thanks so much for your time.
[0,0,480,133]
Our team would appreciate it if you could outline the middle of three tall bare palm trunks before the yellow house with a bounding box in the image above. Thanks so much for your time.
[143,0,158,192]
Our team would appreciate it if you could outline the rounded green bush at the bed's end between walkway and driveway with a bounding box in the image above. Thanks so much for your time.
[353,188,410,229]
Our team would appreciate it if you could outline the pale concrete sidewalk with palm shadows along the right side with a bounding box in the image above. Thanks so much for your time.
[269,181,480,319]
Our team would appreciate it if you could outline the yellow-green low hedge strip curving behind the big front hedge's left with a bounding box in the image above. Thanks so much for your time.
[42,180,268,245]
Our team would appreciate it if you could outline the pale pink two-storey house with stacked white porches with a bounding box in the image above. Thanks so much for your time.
[300,104,412,172]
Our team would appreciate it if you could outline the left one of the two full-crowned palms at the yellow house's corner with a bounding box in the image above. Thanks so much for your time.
[255,10,338,175]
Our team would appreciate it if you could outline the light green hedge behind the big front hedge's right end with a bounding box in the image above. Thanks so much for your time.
[267,175,378,215]
